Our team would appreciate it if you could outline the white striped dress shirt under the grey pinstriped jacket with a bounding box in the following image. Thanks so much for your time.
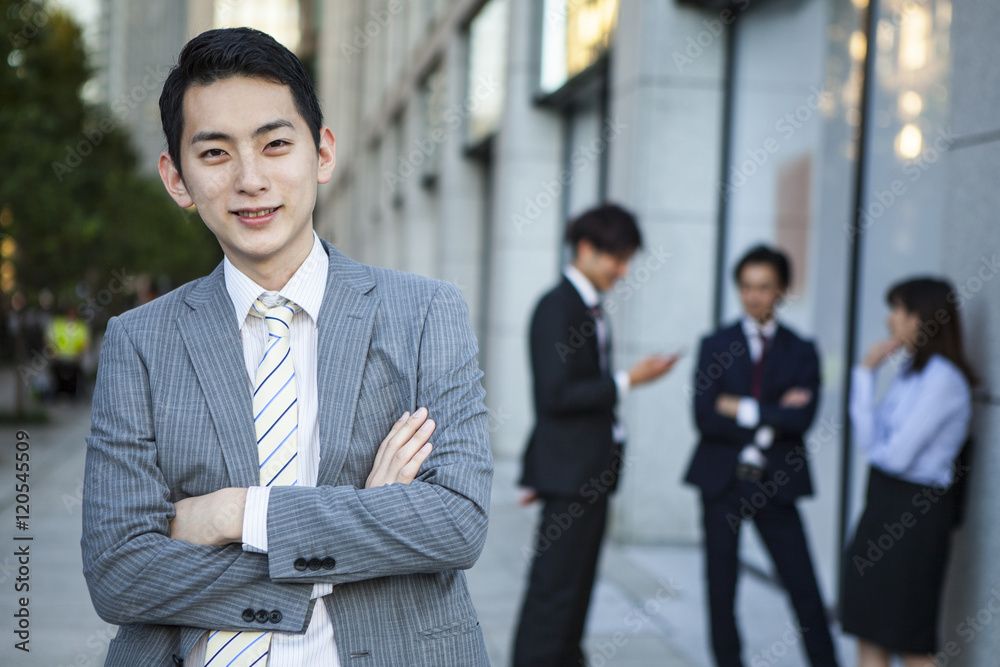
[185,232,340,667]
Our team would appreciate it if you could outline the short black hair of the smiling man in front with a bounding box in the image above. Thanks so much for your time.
[160,28,323,178]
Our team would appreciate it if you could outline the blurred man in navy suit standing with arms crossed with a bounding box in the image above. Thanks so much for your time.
[686,246,837,667]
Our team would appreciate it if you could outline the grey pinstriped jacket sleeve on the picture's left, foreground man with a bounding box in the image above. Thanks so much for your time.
[81,318,311,632]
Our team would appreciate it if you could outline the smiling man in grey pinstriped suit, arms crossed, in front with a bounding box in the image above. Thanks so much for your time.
[82,28,492,667]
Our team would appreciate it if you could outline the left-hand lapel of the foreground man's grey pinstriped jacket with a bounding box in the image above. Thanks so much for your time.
[177,264,260,487]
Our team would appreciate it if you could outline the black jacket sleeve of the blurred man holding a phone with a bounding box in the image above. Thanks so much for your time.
[530,298,618,417]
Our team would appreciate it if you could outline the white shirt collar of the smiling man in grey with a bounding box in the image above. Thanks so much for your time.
[222,231,330,331]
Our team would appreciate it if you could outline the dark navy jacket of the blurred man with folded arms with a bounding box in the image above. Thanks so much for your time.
[684,322,820,502]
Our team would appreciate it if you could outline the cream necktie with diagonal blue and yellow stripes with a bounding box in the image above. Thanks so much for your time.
[205,299,299,667]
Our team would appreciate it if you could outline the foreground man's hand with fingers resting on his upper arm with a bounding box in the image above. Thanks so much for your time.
[365,408,437,489]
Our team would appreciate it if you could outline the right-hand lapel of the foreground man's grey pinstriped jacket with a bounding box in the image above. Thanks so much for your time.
[316,241,379,485]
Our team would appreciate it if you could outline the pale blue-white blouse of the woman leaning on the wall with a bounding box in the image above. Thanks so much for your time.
[850,354,972,487]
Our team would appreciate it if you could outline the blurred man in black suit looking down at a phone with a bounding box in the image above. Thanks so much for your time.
[514,205,677,667]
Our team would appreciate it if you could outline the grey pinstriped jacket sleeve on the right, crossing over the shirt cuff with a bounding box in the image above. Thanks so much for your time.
[267,284,493,583]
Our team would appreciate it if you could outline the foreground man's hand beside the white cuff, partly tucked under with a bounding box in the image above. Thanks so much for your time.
[170,487,247,547]
